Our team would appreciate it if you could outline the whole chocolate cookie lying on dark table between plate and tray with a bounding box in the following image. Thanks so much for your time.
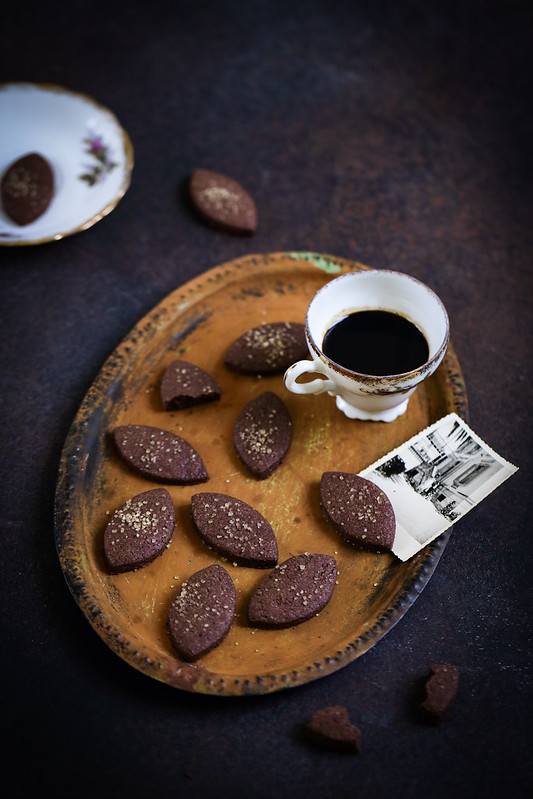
[189,169,257,236]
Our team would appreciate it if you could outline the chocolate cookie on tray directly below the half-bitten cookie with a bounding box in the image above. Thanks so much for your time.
[113,424,208,485]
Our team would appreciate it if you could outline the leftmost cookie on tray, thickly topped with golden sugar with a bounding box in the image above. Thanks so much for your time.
[104,488,176,574]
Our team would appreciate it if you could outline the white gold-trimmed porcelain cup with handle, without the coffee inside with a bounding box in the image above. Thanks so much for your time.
[284,269,450,422]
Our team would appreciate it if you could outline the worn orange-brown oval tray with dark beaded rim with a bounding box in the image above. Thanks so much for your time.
[55,253,467,696]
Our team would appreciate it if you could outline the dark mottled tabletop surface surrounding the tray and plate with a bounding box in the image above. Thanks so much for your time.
[0,0,533,799]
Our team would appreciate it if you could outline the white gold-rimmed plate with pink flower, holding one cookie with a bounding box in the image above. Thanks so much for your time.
[0,83,133,245]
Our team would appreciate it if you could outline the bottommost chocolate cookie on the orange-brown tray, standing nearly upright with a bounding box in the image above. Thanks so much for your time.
[168,563,236,661]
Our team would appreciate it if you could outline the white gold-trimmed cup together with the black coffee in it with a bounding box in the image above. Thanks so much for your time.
[284,269,450,422]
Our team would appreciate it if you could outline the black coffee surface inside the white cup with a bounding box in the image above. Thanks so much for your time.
[322,311,429,376]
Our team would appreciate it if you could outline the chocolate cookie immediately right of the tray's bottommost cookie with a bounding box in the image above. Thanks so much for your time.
[248,553,337,629]
